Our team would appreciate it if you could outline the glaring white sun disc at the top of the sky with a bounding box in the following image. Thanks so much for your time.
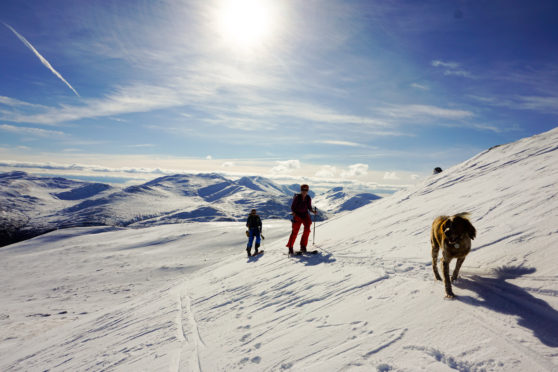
[218,0,274,48]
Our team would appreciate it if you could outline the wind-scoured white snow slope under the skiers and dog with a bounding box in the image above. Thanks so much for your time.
[0,130,558,371]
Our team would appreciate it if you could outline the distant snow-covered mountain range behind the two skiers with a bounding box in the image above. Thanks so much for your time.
[0,172,380,246]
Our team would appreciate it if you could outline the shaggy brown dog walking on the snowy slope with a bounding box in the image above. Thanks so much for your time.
[430,213,477,298]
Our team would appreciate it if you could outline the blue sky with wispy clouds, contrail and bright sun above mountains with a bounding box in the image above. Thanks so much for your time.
[0,0,558,190]
